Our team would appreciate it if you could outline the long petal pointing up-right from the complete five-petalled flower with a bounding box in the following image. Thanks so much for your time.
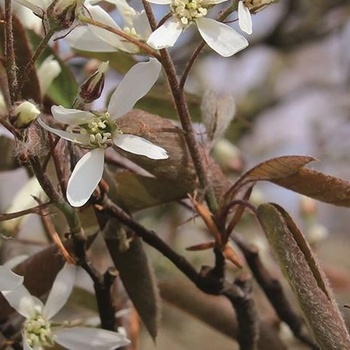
[108,58,161,119]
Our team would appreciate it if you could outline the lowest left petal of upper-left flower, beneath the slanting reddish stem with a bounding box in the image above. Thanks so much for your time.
[65,26,117,52]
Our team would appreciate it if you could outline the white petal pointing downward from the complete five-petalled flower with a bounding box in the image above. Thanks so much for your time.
[67,148,104,207]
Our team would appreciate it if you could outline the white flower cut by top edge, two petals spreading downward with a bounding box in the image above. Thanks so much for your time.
[147,0,248,57]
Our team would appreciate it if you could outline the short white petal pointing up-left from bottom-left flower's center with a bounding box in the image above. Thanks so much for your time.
[2,284,43,318]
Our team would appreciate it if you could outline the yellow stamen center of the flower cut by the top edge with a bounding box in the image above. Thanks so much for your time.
[170,0,208,26]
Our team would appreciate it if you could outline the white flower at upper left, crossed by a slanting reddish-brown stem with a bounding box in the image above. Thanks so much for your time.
[66,0,152,53]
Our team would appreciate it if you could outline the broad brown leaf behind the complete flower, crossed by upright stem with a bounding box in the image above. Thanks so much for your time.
[118,110,230,197]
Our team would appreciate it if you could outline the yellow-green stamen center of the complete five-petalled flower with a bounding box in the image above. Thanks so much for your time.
[80,112,121,148]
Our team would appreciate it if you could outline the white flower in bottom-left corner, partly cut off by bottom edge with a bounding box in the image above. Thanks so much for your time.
[2,264,130,350]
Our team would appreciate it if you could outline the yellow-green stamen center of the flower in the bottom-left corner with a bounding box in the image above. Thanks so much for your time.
[24,314,55,349]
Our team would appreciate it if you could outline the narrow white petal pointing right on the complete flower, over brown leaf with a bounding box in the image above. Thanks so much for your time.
[113,134,169,159]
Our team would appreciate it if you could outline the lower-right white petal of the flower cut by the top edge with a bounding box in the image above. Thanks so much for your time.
[196,18,248,57]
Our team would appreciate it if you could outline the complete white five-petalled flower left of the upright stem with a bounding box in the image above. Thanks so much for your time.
[38,58,168,207]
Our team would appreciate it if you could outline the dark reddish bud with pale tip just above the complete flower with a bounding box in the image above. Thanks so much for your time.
[77,61,109,104]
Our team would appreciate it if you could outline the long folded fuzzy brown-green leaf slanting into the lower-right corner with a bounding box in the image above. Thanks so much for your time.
[257,204,350,350]
